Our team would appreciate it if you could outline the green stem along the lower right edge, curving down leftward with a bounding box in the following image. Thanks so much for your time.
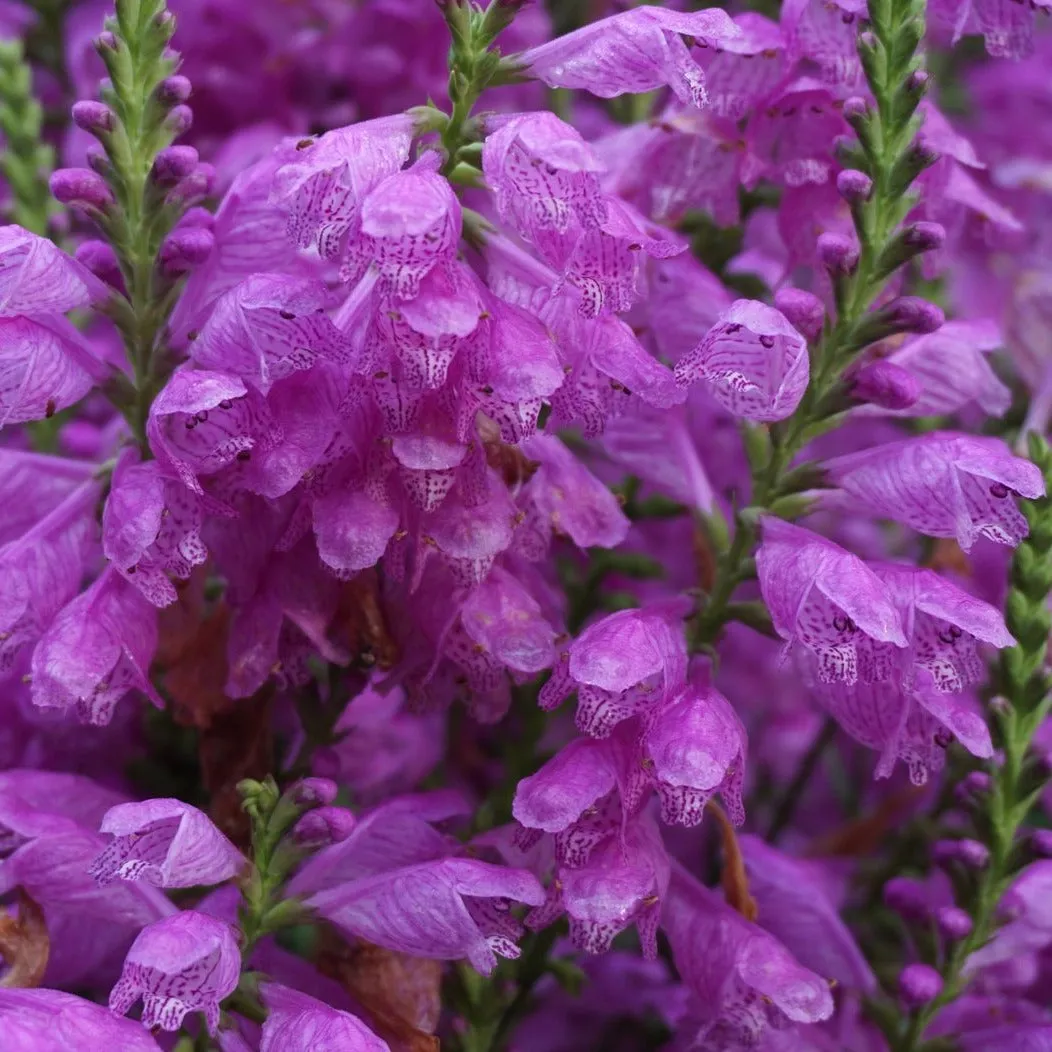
[888,434,1052,1052]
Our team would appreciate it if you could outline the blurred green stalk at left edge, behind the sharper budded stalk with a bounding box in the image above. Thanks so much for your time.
[0,40,55,237]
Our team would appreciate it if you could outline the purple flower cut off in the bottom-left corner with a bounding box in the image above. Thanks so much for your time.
[0,989,161,1052]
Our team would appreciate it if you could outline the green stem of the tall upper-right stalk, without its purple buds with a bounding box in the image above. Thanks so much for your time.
[691,0,931,650]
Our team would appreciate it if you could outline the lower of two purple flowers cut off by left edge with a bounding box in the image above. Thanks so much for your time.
[0,317,106,427]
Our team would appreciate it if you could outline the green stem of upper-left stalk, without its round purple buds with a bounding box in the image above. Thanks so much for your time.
[96,0,188,443]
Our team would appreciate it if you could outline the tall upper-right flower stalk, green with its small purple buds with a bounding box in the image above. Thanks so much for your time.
[691,0,942,650]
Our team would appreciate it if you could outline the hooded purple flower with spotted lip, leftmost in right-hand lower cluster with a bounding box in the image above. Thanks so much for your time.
[756,517,907,686]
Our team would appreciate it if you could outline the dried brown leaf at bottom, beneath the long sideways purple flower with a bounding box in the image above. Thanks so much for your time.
[318,932,442,1052]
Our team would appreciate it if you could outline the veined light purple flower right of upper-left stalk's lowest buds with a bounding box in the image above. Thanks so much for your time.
[190,274,350,395]
